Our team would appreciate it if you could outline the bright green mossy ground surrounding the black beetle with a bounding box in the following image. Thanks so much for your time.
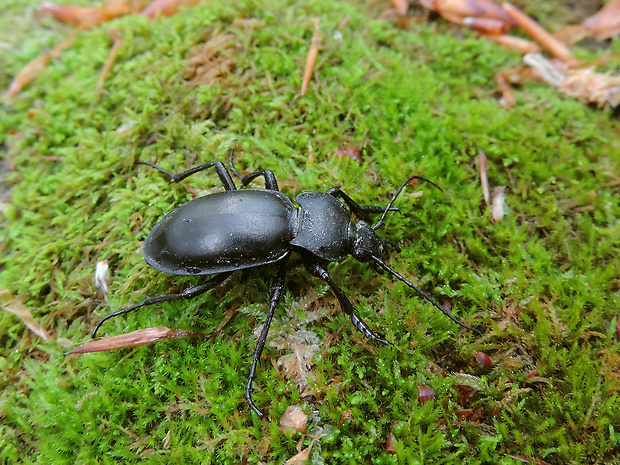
[0,0,620,464]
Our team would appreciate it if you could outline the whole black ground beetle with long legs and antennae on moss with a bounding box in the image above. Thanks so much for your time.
[92,150,471,418]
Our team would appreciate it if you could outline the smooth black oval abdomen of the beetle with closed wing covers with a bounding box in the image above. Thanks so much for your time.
[143,189,297,275]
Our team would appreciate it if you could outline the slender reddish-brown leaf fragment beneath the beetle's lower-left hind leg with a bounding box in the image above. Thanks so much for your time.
[68,326,218,354]
